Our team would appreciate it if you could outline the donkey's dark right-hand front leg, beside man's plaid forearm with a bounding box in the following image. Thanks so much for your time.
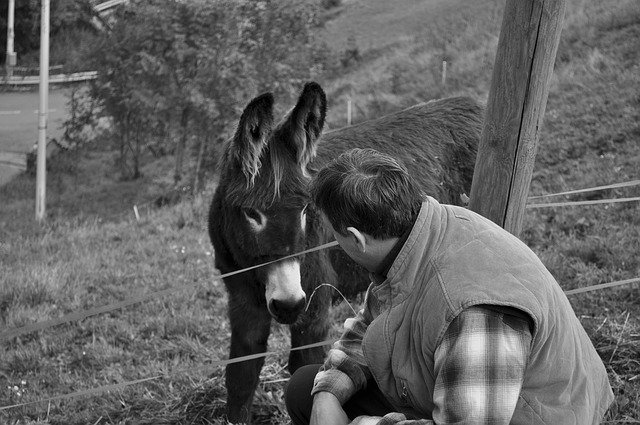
[289,294,329,373]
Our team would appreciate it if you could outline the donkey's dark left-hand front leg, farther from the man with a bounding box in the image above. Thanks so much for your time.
[226,304,271,423]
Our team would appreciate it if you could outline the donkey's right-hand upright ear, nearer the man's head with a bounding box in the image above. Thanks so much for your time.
[281,82,327,170]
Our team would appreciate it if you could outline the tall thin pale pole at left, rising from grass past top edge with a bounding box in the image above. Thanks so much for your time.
[36,0,49,222]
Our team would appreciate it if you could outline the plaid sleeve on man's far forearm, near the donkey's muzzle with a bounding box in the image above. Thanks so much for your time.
[311,284,379,404]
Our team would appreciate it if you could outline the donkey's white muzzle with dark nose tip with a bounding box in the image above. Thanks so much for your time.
[265,258,306,324]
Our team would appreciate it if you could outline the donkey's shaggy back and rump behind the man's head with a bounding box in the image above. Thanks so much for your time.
[313,97,483,205]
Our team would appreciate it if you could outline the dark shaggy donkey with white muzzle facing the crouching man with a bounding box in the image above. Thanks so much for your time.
[209,82,483,423]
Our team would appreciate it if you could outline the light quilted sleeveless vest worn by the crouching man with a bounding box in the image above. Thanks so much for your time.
[363,198,613,425]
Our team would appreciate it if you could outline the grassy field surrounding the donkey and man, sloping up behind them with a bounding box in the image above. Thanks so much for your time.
[0,0,640,424]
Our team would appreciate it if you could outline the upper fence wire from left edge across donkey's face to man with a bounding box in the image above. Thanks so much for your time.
[0,241,338,341]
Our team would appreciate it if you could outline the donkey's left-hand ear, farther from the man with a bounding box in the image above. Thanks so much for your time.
[233,93,273,186]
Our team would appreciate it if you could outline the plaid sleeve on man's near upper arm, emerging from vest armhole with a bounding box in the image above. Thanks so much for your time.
[433,307,531,424]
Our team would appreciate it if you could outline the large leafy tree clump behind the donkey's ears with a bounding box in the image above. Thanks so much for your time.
[82,0,322,185]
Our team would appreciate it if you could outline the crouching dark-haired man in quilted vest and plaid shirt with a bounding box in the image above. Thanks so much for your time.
[286,149,613,425]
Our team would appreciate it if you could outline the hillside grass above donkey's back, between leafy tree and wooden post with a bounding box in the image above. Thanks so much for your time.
[321,0,504,127]
